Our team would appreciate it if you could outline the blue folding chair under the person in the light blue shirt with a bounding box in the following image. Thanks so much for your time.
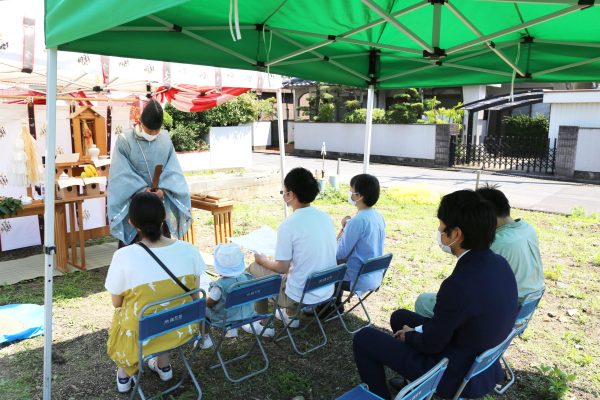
[325,253,392,334]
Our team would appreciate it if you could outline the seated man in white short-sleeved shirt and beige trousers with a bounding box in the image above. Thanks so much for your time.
[248,168,337,328]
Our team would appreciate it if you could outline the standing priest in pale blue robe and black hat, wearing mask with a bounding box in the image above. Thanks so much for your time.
[107,99,191,244]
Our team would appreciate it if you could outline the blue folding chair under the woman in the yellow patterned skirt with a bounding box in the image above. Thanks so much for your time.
[130,289,206,400]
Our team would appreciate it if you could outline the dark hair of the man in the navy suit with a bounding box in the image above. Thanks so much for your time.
[437,190,496,250]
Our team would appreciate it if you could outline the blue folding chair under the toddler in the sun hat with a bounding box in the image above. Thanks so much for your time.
[208,275,281,383]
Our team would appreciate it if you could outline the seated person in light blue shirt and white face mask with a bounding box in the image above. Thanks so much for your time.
[336,174,385,292]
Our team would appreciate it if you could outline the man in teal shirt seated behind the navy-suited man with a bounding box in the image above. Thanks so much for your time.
[415,187,544,318]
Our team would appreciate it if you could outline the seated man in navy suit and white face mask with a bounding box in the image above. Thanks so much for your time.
[353,190,518,399]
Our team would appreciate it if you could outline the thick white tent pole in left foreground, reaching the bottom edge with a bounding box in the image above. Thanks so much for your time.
[43,48,57,400]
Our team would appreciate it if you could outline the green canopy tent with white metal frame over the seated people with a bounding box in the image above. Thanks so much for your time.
[44,0,600,398]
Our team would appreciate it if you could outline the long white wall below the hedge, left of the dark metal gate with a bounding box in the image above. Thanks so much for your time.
[294,122,436,160]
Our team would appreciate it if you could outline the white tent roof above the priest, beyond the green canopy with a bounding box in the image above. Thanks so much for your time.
[0,0,281,97]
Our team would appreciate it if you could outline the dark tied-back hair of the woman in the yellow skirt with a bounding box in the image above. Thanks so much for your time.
[129,192,165,242]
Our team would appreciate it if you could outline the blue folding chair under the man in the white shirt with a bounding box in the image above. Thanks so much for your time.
[274,264,346,356]
